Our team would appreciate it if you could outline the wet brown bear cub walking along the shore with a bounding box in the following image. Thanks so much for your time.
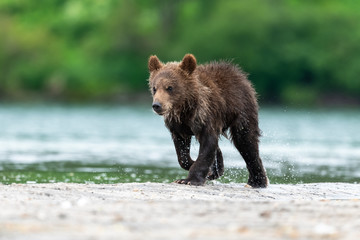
[148,54,268,188]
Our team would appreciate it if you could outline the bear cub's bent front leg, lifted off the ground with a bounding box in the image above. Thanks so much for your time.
[171,132,194,170]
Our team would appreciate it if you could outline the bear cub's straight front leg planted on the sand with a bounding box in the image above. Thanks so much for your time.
[175,133,218,186]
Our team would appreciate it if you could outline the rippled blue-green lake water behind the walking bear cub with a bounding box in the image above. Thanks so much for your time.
[0,104,360,184]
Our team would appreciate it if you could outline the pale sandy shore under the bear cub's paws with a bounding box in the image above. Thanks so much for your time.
[0,183,360,240]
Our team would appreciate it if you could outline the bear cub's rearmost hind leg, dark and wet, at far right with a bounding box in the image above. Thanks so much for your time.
[230,126,268,188]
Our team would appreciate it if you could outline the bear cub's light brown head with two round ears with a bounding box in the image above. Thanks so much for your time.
[148,54,196,117]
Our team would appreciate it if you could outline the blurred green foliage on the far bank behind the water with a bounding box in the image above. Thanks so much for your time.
[0,0,360,105]
